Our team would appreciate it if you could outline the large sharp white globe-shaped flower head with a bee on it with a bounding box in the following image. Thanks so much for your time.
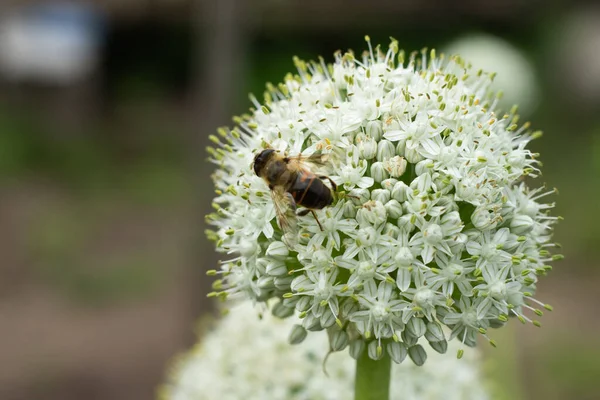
[207,37,561,363]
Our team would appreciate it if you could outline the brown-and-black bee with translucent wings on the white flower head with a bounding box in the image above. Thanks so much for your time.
[254,148,337,233]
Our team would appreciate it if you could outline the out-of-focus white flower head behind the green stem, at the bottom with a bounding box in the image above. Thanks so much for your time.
[160,303,489,400]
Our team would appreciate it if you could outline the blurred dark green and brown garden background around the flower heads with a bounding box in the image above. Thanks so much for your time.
[0,0,600,400]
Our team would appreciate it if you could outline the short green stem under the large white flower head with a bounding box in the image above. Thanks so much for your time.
[354,350,392,400]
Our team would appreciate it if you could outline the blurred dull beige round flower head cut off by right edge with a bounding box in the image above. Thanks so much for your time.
[551,5,600,108]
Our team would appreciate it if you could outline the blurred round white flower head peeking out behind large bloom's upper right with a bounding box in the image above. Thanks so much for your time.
[443,34,539,115]
